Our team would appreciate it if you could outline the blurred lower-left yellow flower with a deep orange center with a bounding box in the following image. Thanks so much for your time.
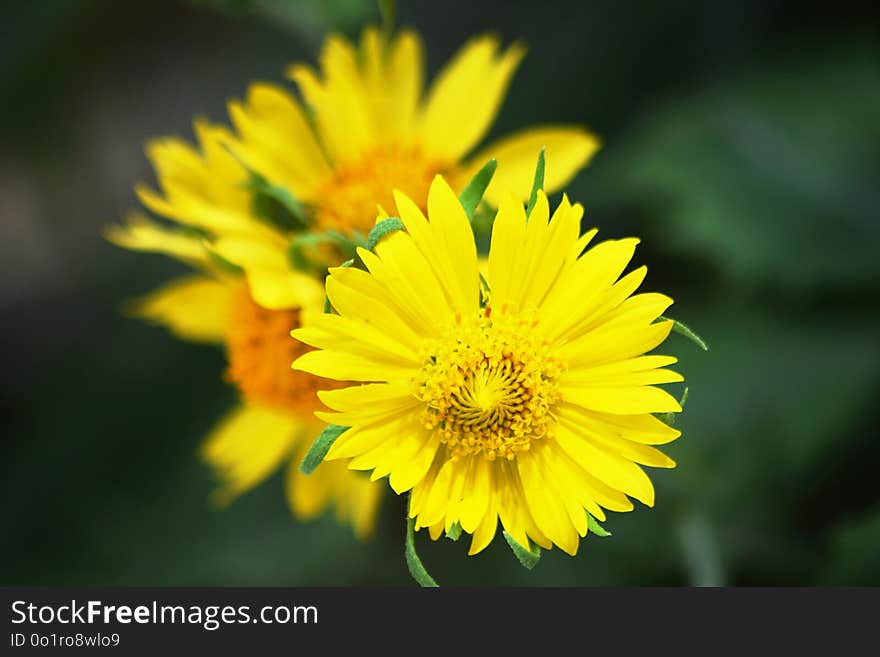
[110,246,382,537]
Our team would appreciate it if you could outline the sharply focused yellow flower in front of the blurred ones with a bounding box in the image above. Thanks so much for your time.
[293,176,683,554]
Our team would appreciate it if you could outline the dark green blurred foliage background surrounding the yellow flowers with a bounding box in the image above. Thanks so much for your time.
[0,0,880,585]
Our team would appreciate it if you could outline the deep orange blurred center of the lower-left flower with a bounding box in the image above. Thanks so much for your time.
[226,286,345,415]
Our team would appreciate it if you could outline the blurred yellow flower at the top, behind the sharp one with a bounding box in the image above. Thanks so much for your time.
[127,28,599,308]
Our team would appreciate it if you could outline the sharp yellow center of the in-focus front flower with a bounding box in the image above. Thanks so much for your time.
[416,307,564,461]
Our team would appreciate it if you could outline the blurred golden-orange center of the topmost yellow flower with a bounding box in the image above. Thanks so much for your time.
[315,146,440,235]
